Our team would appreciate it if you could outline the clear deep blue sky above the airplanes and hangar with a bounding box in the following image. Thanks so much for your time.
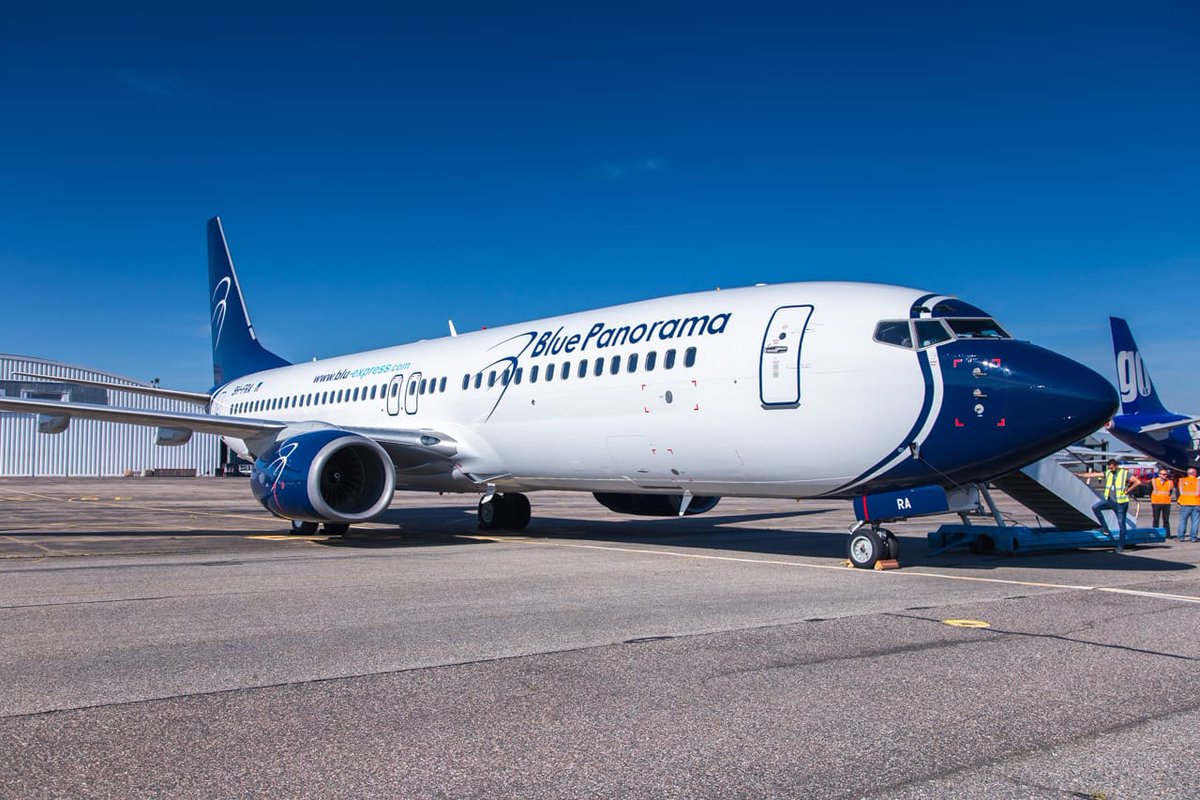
[0,1,1200,400]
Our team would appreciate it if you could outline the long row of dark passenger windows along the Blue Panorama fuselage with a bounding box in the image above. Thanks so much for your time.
[230,347,696,414]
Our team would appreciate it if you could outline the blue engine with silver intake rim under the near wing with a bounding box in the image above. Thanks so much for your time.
[250,428,396,522]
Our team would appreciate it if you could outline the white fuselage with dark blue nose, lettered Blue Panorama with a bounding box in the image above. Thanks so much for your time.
[211,282,1115,498]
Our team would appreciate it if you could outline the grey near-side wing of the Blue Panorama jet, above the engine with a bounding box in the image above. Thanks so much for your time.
[0,397,458,471]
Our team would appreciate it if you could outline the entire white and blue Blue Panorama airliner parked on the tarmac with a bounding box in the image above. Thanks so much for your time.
[0,218,1117,566]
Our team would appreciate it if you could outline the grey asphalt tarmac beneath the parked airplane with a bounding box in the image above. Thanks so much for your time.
[0,479,1200,799]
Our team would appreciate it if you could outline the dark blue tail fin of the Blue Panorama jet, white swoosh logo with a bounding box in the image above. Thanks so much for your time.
[209,217,288,386]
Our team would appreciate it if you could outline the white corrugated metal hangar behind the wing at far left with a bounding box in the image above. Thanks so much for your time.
[0,354,221,477]
